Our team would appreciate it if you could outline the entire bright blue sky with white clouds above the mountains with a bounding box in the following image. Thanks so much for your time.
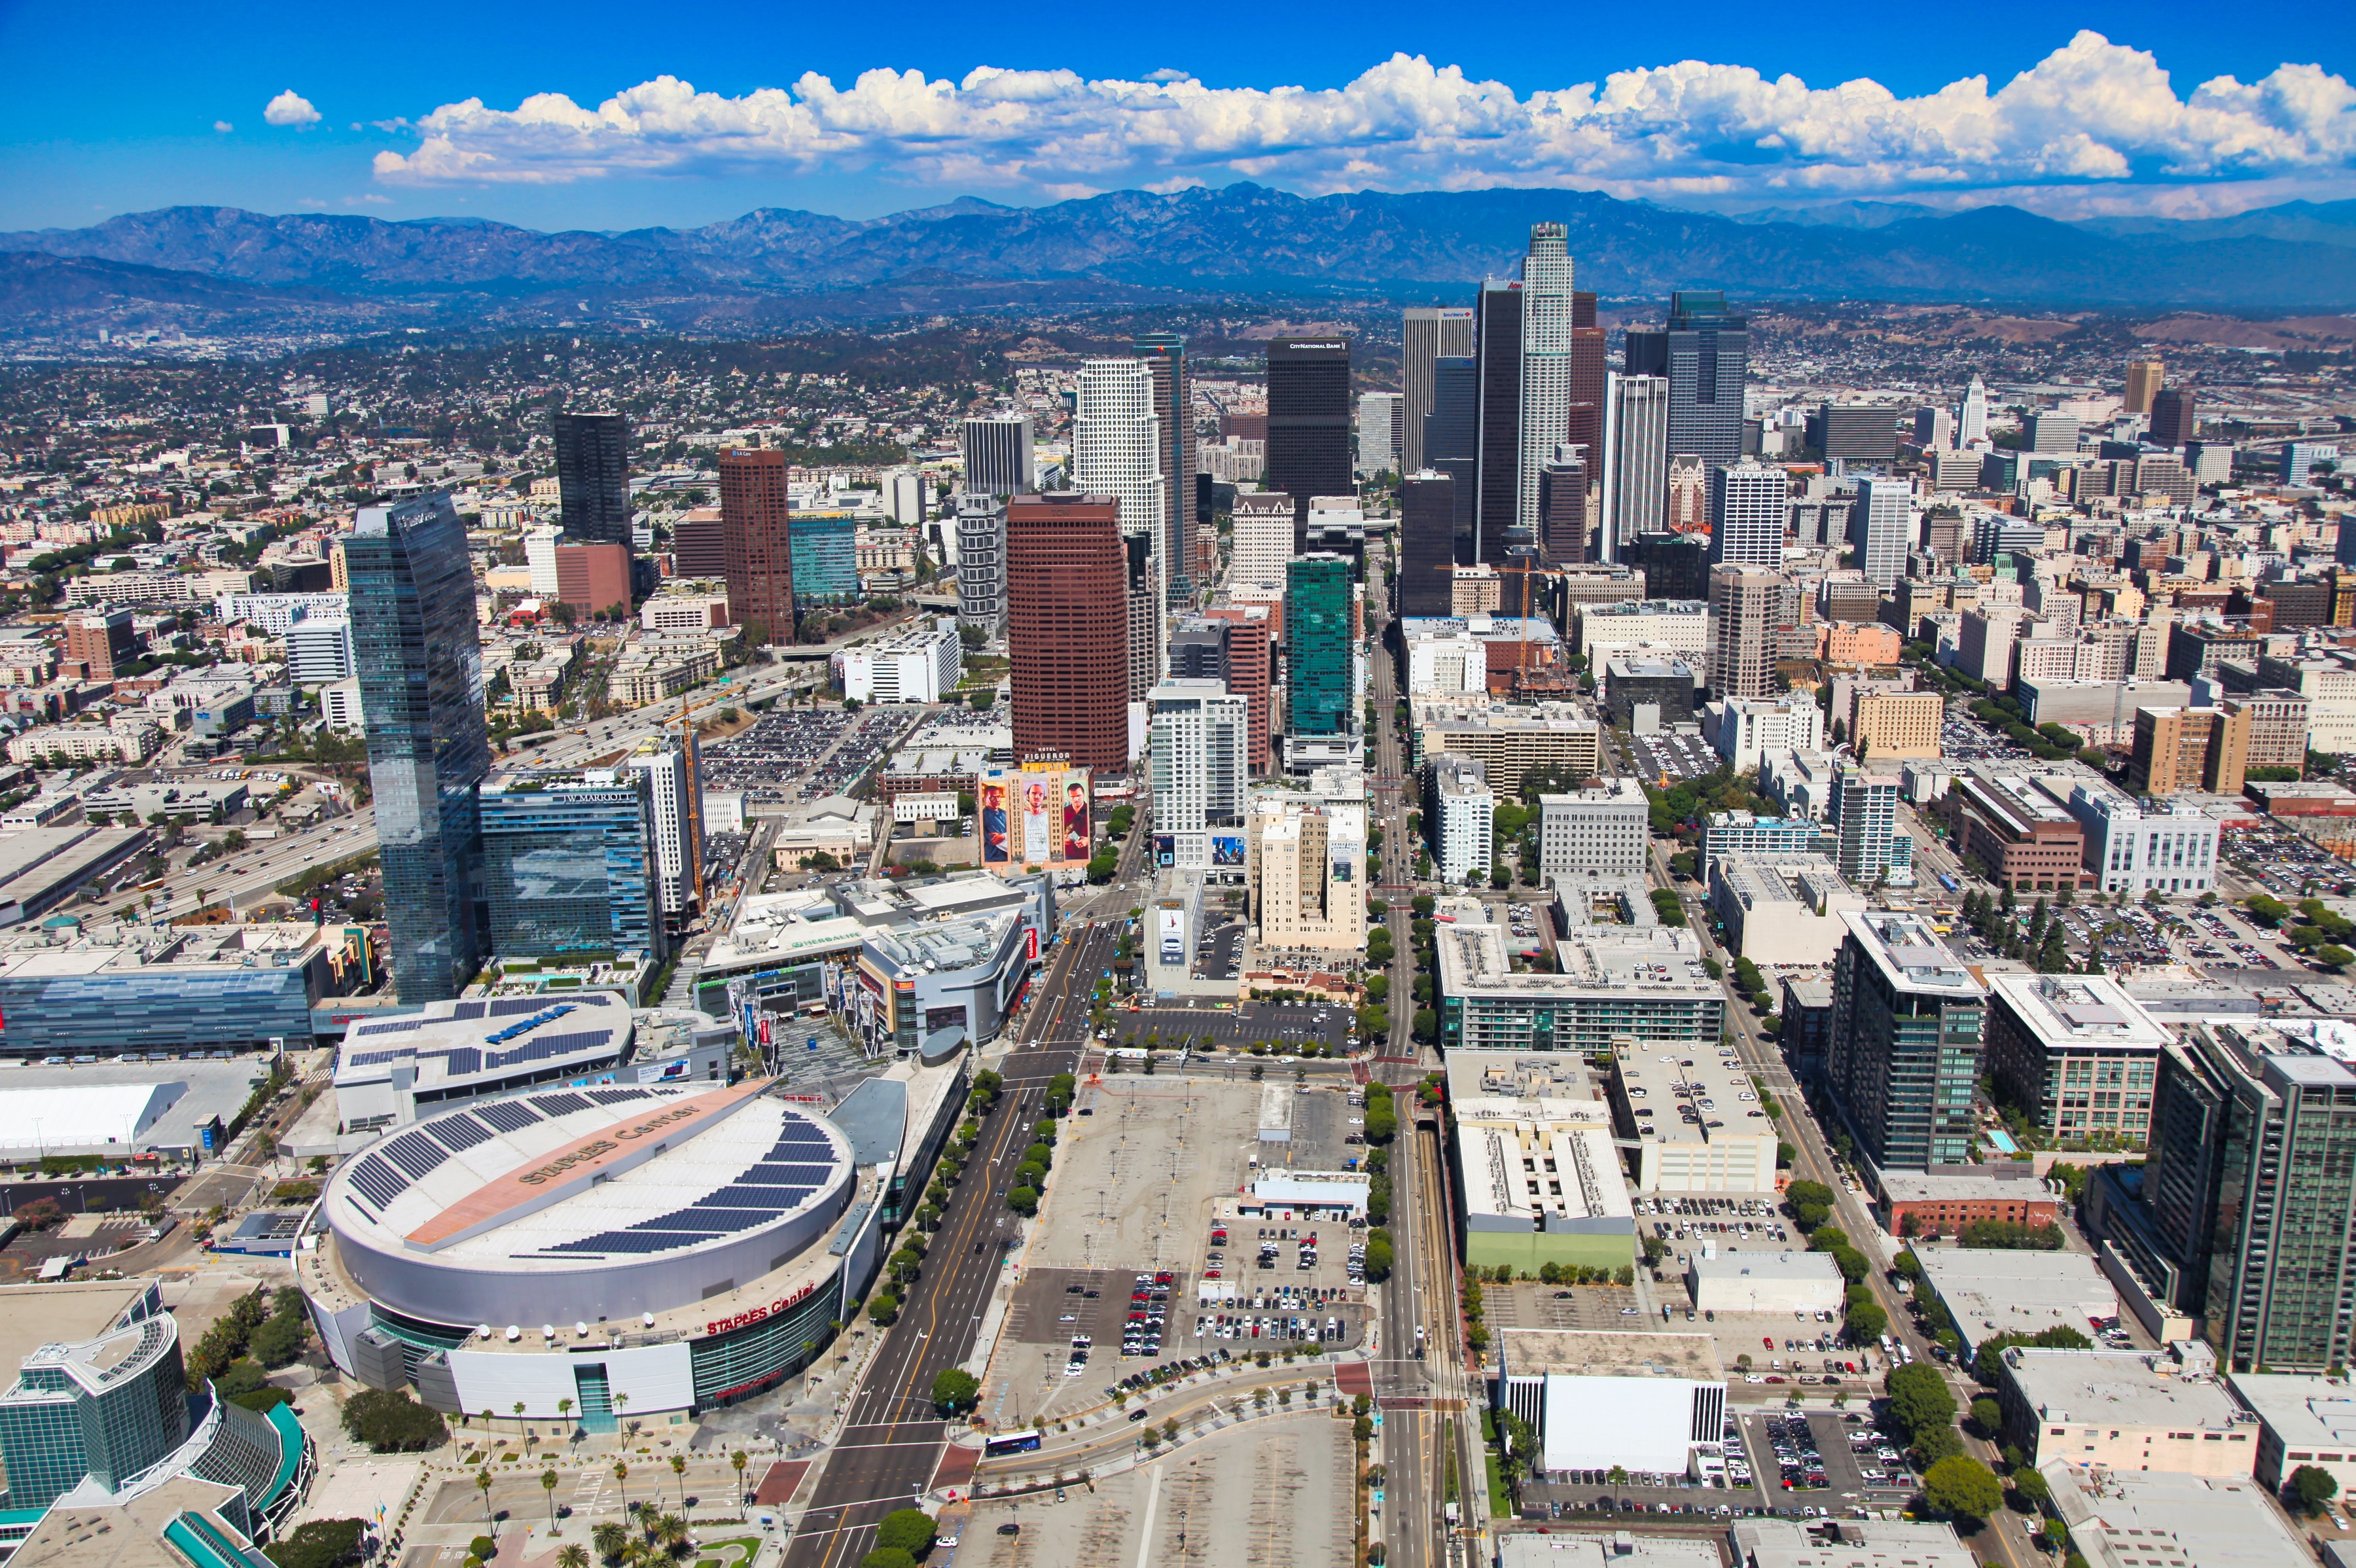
[0,0,2356,228]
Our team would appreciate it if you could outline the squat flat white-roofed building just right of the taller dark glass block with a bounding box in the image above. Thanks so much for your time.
[1986,974,2168,1149]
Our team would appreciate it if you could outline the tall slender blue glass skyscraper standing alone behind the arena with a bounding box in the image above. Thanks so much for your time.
[344,492,490,1003]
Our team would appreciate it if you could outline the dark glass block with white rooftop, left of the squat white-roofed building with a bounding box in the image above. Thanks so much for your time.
[1826,911,1988,1170]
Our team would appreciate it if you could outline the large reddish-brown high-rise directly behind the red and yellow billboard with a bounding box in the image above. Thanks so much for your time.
[1006,492,1128,772]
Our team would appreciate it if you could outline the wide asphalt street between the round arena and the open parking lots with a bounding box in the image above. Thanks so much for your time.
[785,925,1115,1568]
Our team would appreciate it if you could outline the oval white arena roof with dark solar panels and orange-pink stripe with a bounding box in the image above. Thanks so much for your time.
[323,1083,855,1325]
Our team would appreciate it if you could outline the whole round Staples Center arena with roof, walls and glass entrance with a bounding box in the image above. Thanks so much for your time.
[297,1083,891,1434]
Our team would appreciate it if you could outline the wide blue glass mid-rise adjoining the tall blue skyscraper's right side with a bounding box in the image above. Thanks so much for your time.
[480,768,669,963]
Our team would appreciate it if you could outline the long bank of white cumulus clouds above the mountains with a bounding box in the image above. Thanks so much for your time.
[367,31,2356,200]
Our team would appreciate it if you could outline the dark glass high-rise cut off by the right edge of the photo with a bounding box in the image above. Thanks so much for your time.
[2144,1020,2356,1372]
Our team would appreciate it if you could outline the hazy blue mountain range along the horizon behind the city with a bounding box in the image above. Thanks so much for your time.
[0,184,2356,336]
